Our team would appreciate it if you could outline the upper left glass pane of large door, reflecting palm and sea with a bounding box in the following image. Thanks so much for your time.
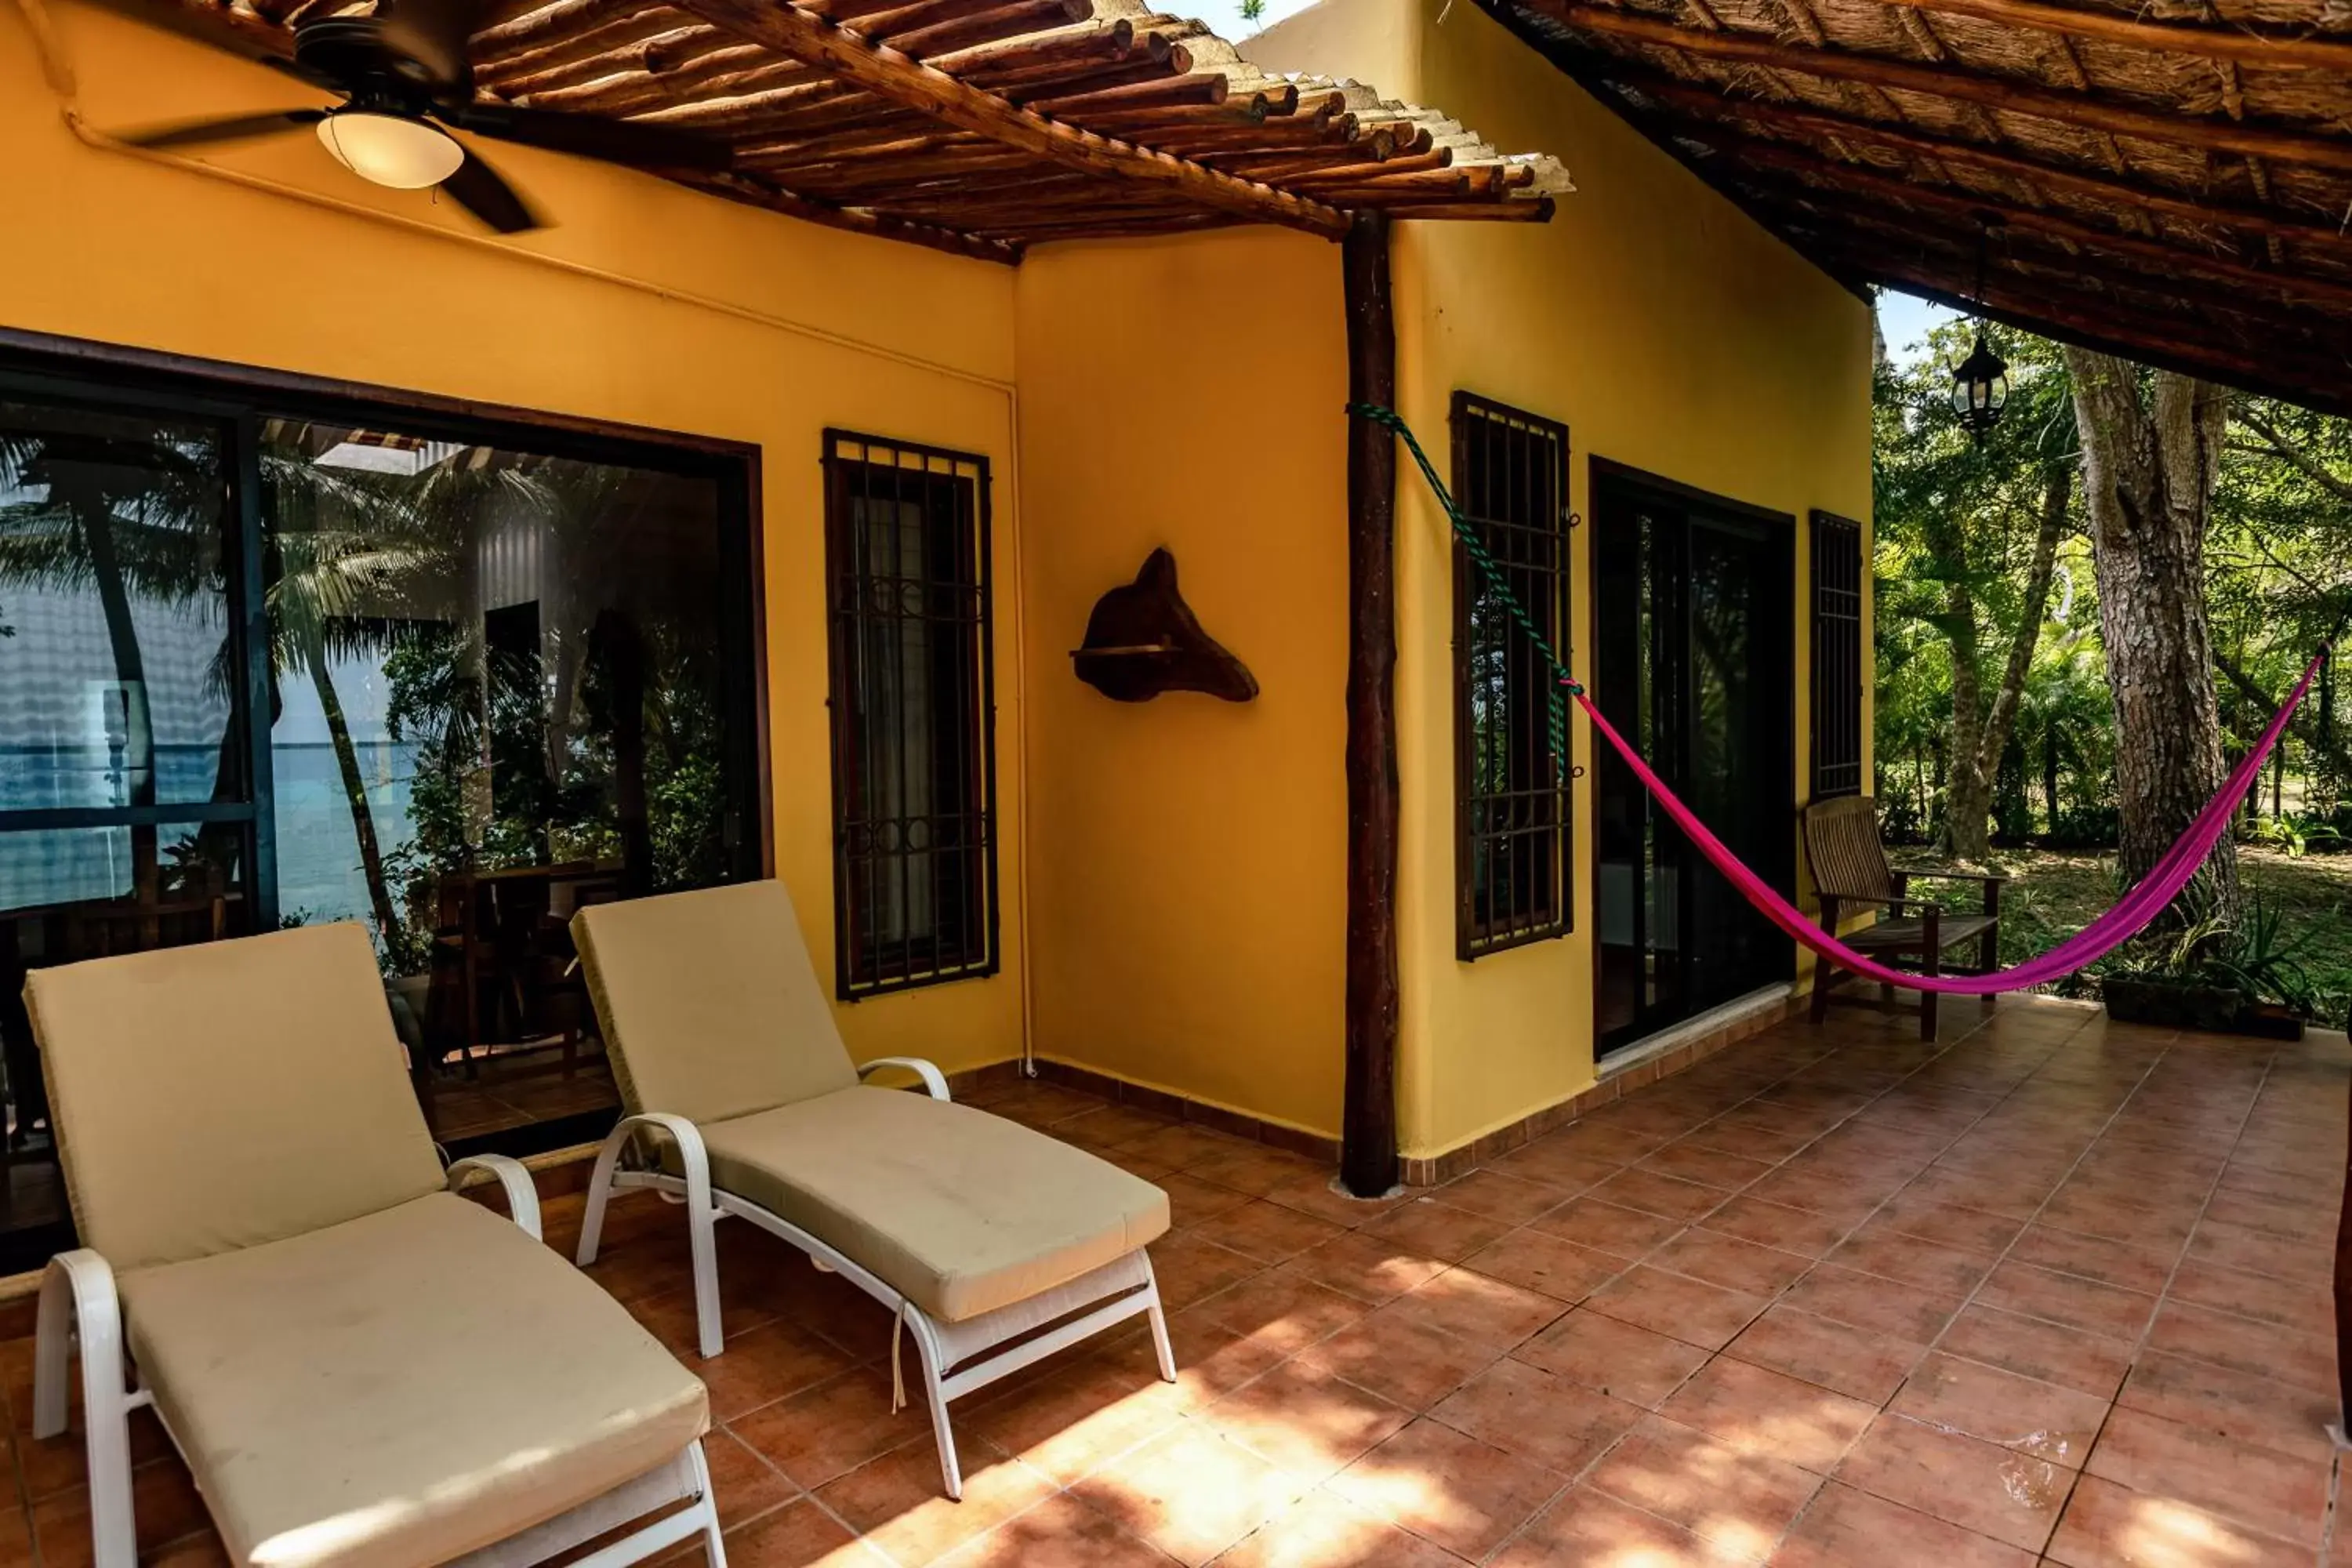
[0,402,245,832]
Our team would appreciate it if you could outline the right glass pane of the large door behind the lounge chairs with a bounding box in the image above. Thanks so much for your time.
[261,421,741,1140]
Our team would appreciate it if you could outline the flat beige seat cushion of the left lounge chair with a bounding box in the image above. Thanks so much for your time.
[120,1182,710,1568]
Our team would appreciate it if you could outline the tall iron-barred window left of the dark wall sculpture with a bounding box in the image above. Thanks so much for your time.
[826,430,997,999]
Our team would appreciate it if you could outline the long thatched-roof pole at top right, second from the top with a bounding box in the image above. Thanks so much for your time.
[1517,0,2352,172]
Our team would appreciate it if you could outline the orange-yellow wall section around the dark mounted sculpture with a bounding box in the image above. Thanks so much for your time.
[1018,230,1348,1135]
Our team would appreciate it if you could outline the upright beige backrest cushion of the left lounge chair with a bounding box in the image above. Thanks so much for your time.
[24,924,442,1272]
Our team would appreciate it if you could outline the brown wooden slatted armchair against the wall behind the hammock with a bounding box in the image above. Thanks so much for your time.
[1804,794,2009,1039]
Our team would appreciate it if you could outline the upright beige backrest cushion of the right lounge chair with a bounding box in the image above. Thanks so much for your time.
[572,881,858,1121]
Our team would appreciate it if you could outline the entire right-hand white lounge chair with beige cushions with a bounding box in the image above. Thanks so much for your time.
[572,881,1176,1497]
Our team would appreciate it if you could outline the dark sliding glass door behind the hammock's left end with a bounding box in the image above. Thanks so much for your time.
[1592,463,1795,1051]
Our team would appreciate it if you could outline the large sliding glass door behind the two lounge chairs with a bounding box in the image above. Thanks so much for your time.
[0,350,760,1267]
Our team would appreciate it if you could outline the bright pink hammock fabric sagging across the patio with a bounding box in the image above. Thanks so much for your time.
[1569,647,2328,996]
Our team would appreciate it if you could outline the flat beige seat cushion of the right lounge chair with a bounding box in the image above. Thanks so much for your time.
[701,1088,1169,1323]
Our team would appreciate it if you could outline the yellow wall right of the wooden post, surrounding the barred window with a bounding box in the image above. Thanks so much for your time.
[1247,0,1870,1154]
